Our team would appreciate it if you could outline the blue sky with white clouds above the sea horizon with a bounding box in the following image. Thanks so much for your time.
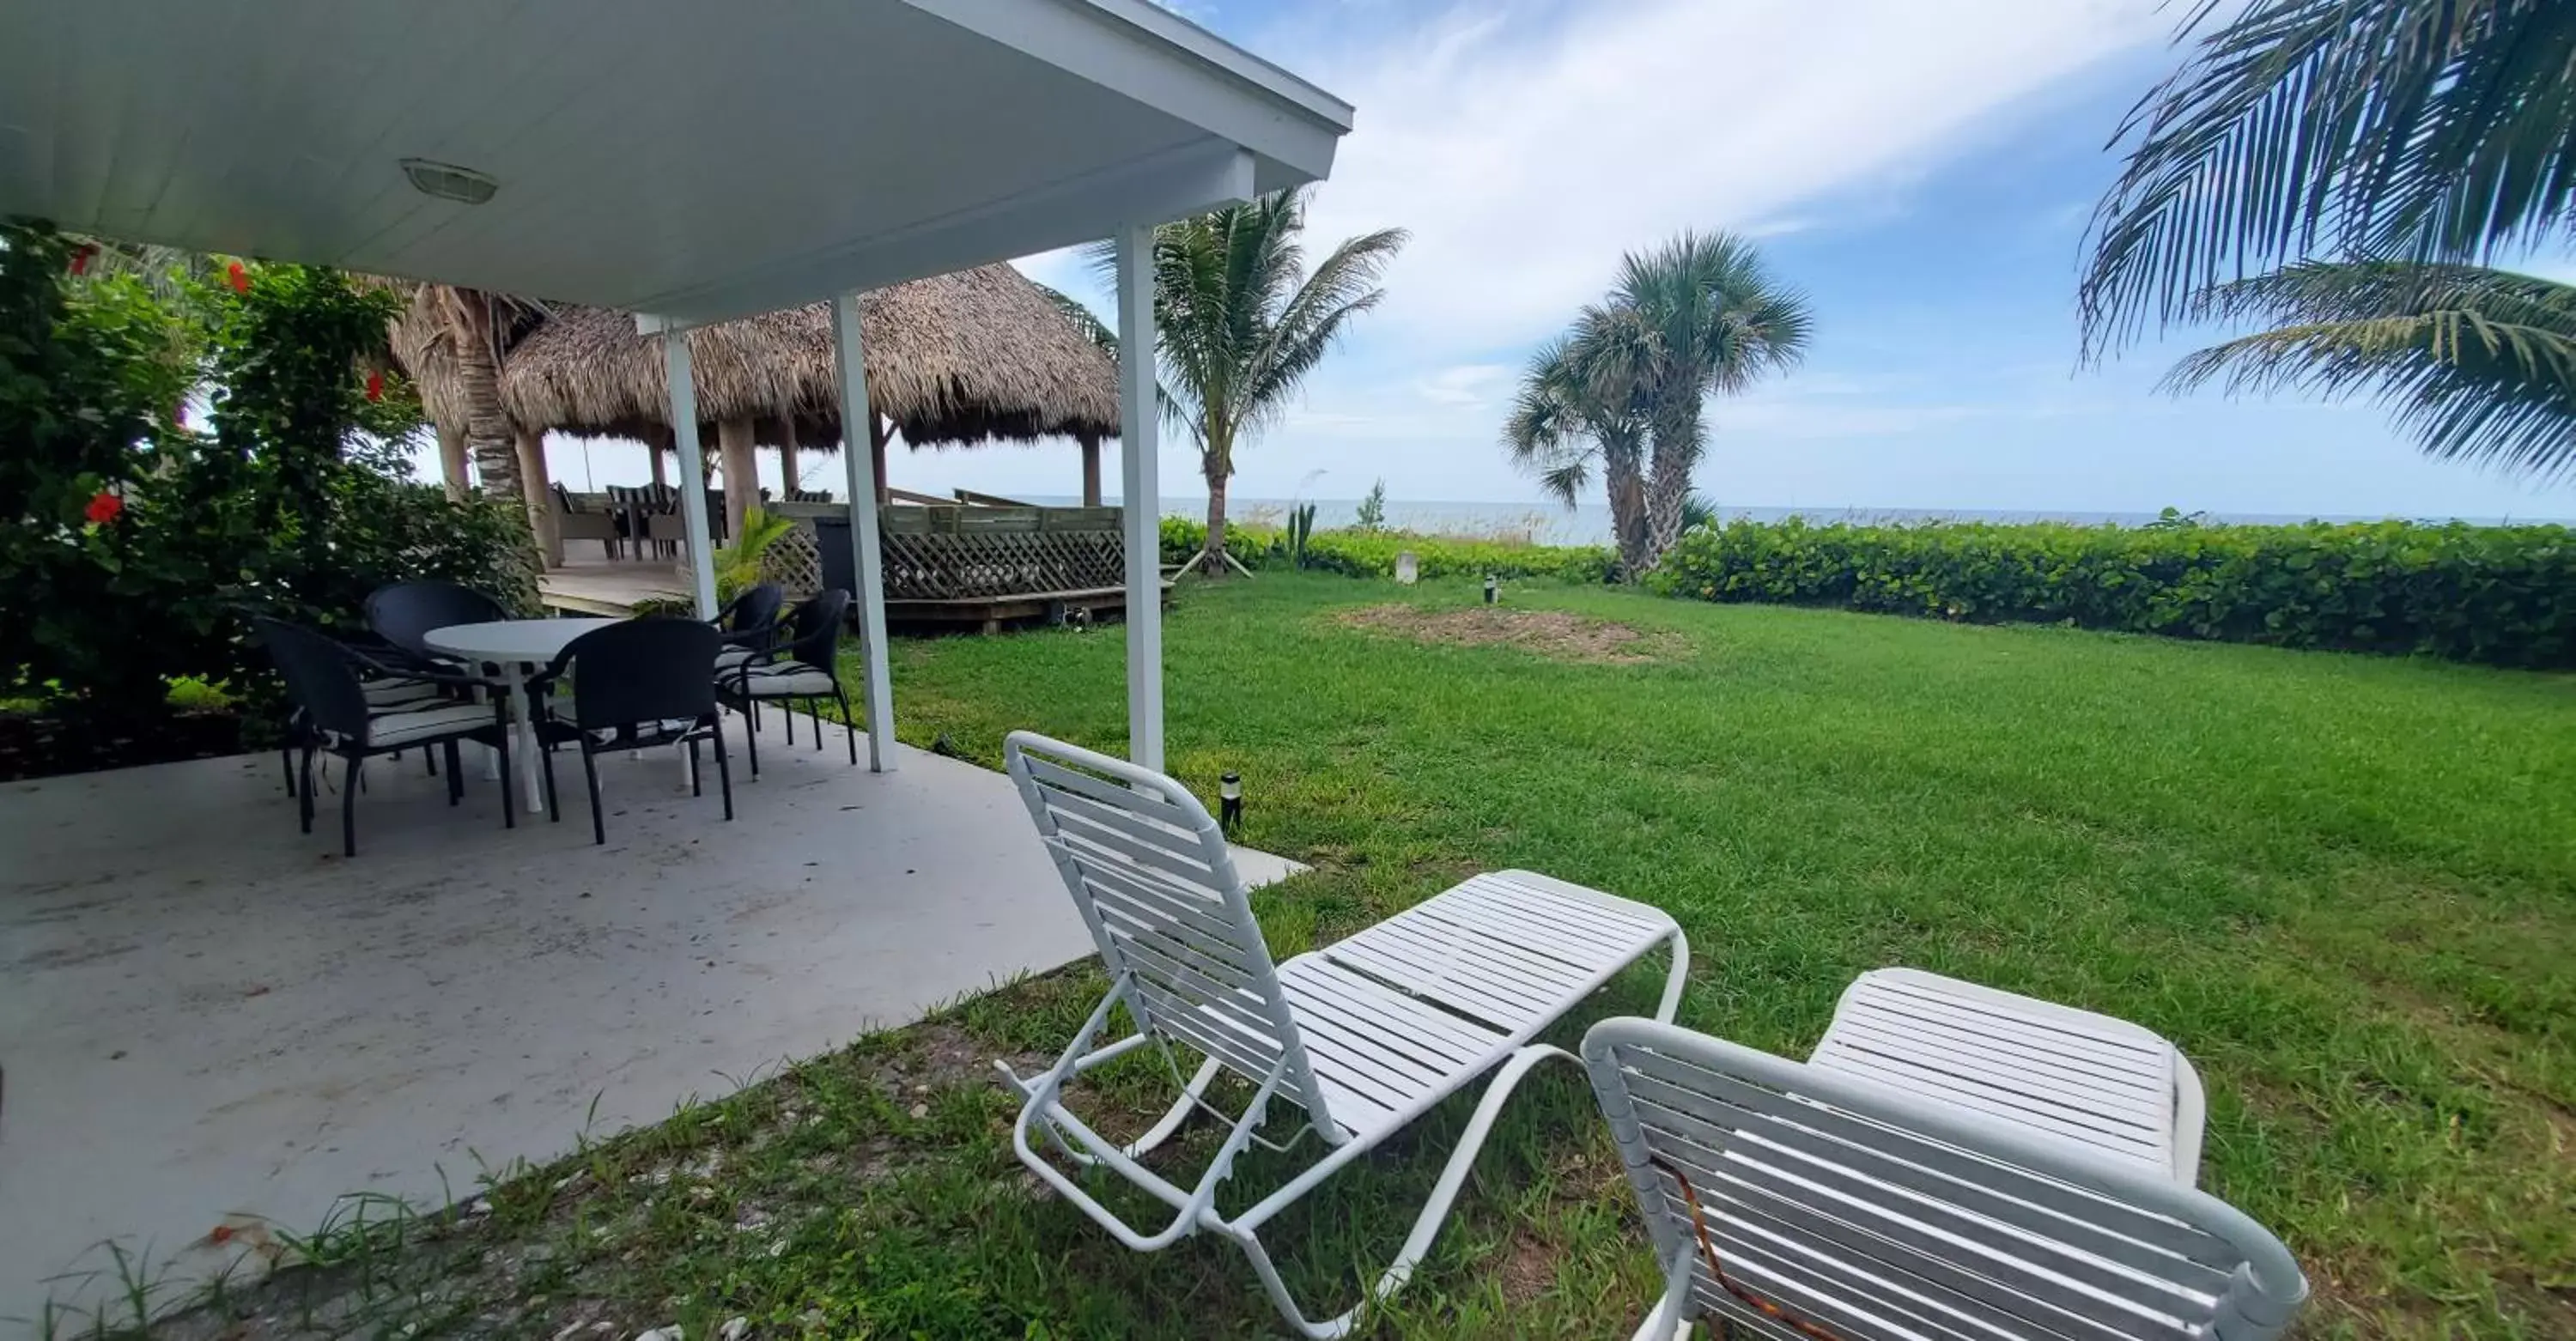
[528,0,2576,518]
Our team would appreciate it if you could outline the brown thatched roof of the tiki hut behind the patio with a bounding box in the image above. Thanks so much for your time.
[502,265,1118,465]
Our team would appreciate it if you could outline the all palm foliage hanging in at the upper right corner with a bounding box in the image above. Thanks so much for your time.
[2081,0,2576,474]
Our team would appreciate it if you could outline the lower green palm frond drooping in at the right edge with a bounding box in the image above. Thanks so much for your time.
[2166,263,2576,476]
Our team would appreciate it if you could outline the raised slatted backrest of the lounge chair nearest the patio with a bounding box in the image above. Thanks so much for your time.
[1002,731,1334,1132]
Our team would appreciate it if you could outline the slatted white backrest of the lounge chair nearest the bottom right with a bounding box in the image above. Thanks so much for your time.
[1584,1019,2308,1341]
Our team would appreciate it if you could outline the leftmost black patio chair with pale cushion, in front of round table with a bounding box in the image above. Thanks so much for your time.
[252,618,518,857]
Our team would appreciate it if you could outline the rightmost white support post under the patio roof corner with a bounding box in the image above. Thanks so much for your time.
[1118,224,1162,772]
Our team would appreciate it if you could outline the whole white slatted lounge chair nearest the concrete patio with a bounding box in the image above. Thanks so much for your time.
[1002,731,1690,1338]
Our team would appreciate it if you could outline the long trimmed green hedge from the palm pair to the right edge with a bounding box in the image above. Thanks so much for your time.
[1649,518,2576,667]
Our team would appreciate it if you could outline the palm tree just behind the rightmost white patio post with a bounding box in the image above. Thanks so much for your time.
[1092,188,1404,572]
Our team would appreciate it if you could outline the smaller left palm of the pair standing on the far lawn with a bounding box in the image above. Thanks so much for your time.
[1502,328,1654,574]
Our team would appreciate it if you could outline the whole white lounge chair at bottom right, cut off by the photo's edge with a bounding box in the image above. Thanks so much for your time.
[1584,968,2308,1341]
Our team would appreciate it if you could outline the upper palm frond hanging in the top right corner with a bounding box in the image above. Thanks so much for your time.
[2081,0,2576,358]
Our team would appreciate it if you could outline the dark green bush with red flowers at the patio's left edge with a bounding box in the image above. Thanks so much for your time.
[0,224,536,720]
